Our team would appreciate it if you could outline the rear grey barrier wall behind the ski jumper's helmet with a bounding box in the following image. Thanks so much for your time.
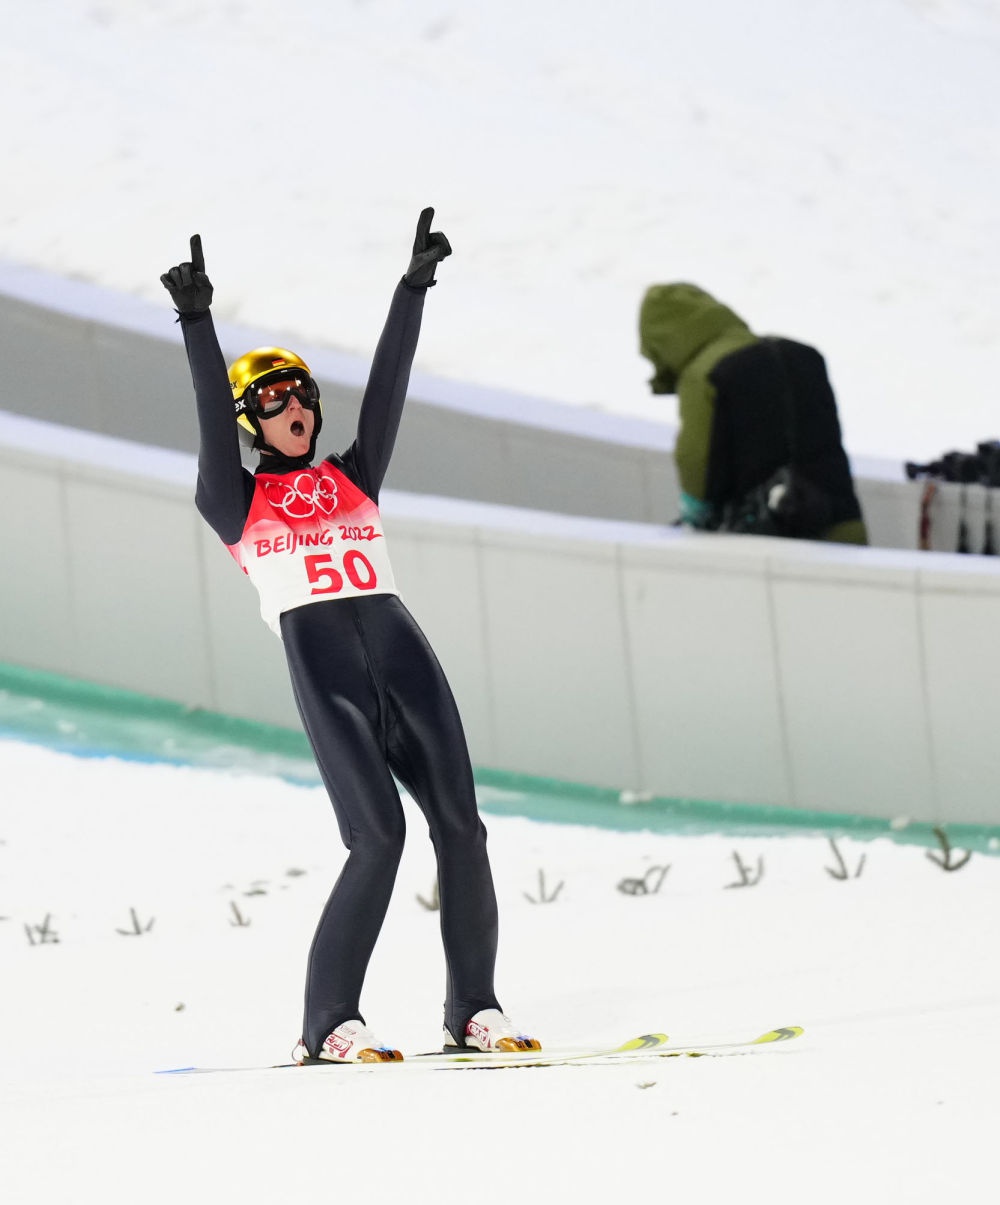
[0,260,1000,551]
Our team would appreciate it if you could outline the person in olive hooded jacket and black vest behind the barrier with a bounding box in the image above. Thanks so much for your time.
[639,283,867,543]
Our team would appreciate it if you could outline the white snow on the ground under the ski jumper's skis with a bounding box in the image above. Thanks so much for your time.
[0,740,1000,1205]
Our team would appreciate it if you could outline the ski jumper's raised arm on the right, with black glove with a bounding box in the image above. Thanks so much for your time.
[345,208,452,501]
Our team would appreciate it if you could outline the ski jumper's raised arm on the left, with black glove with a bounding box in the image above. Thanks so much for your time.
[160,235,253,543]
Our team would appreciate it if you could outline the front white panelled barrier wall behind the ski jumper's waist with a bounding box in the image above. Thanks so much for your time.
[0,415,1000,824]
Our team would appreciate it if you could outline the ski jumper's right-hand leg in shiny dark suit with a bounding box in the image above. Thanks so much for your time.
[366,599,500,1041]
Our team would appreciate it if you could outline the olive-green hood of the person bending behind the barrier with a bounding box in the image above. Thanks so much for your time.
[639,283,753,393]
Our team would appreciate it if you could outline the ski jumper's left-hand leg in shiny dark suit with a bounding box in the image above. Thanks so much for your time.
[282,600,405,1054]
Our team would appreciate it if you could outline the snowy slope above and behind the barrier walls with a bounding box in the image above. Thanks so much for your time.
[0,0,1000,460]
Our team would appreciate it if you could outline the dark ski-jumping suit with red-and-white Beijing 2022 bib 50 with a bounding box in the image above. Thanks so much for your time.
[181,282,500,1054]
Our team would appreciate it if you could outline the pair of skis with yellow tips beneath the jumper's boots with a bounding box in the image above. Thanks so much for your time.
[155,1025,805,1075]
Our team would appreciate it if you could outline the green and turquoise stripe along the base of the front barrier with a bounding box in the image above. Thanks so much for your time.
[0,663,1000,854]
